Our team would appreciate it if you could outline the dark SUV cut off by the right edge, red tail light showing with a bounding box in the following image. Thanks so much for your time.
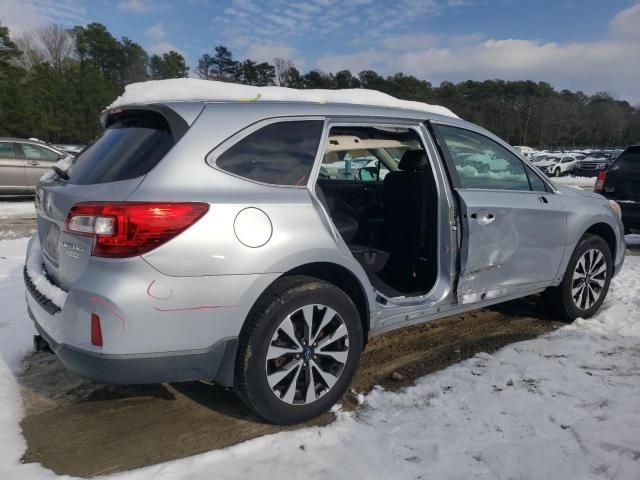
[594,145,640,231]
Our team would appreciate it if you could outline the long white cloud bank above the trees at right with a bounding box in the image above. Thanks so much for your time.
[316,4,640,102]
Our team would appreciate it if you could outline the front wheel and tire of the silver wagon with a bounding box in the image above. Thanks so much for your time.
[543,234,613,322]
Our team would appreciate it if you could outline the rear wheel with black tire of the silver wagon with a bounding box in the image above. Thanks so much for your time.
[235,276,363,424]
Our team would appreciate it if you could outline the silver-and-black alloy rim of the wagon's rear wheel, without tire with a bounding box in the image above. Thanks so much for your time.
[265,304,349,405]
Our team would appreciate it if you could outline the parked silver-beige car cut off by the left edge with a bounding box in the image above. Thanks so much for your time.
[0,137,65,196]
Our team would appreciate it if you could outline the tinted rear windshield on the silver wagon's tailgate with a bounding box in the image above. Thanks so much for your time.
[69,110,175,185]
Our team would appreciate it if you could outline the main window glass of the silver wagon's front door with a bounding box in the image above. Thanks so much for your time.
[438,125,530,190]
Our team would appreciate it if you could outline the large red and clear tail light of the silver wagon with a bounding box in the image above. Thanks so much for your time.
[65,202,209,258]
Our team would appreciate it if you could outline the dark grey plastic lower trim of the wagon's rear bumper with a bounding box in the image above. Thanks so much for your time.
[29,309,238,387]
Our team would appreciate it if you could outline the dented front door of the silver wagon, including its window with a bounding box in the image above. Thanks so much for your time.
[435,125,566,303]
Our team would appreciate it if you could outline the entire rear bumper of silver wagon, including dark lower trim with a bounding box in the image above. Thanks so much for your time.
[25,232,277,386]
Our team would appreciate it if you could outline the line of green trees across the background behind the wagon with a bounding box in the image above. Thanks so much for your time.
[0,23,640,148]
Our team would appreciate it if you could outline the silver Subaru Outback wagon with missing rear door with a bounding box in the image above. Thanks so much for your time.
[24,91,625,423]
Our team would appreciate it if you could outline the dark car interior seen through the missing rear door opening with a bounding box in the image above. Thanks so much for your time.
[315,126,438,298]
